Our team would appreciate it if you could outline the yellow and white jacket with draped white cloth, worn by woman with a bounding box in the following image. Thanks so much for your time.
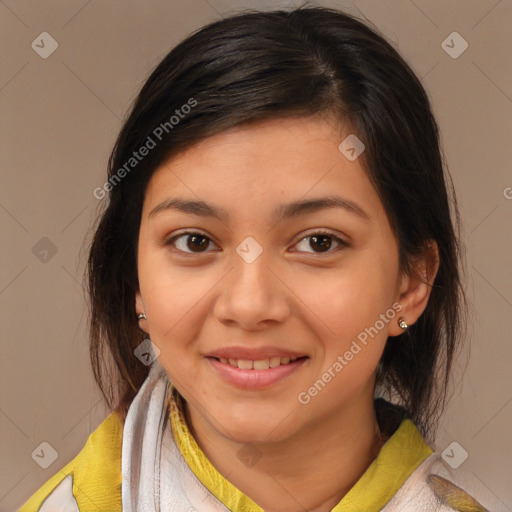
[18,360,507,512]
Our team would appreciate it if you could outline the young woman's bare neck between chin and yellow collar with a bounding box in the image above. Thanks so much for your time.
[185,389,387,512]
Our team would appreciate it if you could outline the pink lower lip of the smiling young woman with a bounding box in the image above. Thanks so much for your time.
[207,357,308,389]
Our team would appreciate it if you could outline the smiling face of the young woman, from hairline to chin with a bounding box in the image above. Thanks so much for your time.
[136,118,408,442]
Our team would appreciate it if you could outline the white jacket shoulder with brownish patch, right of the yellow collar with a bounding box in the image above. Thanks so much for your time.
[383,453,508,512]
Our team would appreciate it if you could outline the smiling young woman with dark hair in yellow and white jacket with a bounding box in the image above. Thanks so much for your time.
[20,8,498,512]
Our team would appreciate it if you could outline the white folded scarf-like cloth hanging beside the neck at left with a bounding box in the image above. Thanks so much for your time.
[121,359,229,512]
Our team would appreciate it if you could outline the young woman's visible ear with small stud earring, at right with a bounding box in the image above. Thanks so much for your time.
[389,240,439,336]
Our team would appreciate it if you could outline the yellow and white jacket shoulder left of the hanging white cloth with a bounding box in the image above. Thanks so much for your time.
[18,412,123,512]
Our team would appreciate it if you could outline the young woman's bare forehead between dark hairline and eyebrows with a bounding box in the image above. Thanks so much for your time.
[144,118,384,223]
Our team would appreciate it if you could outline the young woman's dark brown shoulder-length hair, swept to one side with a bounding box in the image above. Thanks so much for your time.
[87,6,465,444]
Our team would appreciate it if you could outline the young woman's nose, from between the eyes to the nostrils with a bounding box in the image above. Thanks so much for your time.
[214,254,291,331]
